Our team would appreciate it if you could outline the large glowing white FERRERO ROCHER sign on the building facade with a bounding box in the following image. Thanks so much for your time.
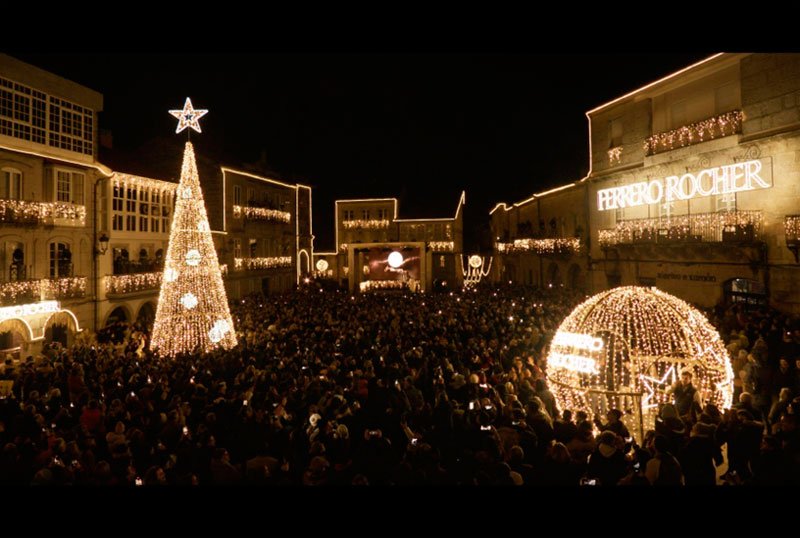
[597,160,772,211]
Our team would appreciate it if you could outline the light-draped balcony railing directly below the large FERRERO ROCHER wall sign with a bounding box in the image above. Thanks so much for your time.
[599,211,763,247]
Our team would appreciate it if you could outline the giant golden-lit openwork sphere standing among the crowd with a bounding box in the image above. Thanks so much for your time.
[547,286,733,437]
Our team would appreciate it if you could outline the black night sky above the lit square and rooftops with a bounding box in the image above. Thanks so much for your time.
[10,51,709,251]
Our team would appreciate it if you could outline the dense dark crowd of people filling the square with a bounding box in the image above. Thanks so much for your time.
[0,285,800,486]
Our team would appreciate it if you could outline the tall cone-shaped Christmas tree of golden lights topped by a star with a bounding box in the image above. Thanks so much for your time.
[150,99,236,357]
